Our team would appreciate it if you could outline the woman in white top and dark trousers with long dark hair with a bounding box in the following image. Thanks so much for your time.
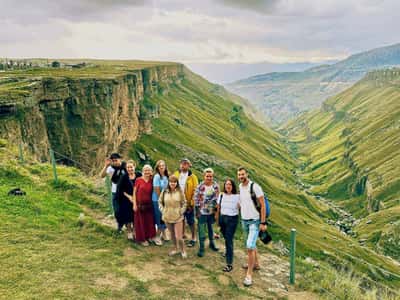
[217,179,239,272]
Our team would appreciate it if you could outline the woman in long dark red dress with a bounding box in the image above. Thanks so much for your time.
[133,165,156,246]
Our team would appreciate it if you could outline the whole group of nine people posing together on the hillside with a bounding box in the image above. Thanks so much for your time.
[101,153,267,286]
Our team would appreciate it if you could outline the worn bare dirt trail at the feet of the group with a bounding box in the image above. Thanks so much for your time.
[90,211,318,300]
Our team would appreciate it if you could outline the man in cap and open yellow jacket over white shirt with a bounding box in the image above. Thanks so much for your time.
[174,158,199,247]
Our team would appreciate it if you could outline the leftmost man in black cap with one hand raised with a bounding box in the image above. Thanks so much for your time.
[100,153,126,232]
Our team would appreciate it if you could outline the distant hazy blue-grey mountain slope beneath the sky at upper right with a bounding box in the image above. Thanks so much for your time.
[227,44,400,125]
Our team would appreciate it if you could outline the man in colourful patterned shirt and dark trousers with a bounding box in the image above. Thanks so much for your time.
[194,168,219,257]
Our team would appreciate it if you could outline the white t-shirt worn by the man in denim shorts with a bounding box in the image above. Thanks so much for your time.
[239,181,264,220]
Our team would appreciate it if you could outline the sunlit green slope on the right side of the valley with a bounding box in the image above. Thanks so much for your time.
[285,69,400,259]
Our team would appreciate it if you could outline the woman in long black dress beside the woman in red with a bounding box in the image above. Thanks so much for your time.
[117,160,142,240]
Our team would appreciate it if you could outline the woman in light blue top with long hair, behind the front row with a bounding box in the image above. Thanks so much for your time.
[152,160,169,246]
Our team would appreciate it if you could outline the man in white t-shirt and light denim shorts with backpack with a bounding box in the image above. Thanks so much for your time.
[237,167,267,286]
